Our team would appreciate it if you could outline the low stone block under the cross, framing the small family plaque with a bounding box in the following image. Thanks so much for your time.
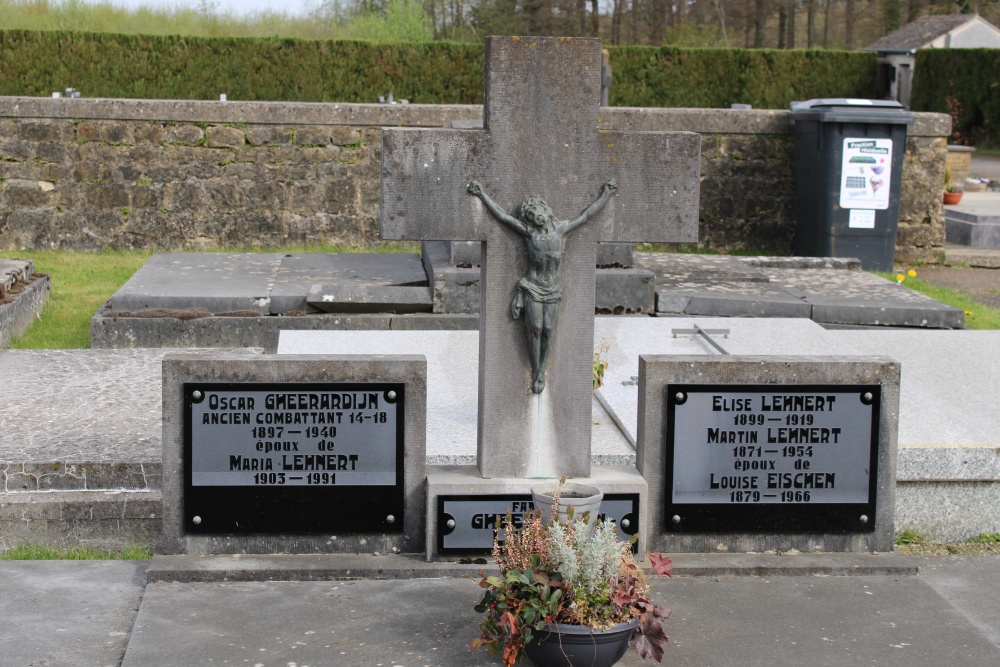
[426,465,649,561]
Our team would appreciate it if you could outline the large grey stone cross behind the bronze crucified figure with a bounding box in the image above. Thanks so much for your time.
[381,37,701,478]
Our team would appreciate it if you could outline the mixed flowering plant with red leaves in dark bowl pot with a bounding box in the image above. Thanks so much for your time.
[472,496,672,667]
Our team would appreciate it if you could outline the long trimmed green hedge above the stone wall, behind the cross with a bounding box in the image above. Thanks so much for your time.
[0,31,876,109]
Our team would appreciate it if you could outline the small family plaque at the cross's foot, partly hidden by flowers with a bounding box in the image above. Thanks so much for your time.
[437,493,639,555]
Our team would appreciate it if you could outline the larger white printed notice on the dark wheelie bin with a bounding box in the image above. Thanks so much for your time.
[840,138,892,211]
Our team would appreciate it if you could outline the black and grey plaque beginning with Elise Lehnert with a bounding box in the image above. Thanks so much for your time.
[663,384,881,534]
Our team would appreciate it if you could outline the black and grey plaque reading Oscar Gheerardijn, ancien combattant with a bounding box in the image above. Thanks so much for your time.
[183,382,405,534]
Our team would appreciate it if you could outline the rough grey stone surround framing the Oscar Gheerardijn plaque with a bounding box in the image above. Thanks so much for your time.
[157,351,427,554]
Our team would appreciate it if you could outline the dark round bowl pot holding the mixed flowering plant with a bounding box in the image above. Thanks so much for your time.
[524,619,639,667]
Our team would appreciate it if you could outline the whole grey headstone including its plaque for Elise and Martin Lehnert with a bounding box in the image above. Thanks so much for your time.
[636,355,900,552]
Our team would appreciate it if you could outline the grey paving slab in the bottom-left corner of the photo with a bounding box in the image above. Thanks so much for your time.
[0,561,146,667]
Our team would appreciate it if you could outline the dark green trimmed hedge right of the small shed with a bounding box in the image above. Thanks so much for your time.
[910,49,1000,147]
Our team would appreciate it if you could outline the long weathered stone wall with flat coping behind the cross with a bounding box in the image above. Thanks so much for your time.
[0,97,951,261]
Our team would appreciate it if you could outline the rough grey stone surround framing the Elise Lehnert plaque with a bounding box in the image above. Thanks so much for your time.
[636,355,900,553]
